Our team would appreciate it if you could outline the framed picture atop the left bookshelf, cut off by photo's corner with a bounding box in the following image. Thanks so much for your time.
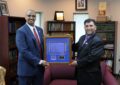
[0,1,9,16]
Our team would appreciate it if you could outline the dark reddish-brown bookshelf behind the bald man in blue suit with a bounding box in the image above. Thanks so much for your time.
[0,16,25,85]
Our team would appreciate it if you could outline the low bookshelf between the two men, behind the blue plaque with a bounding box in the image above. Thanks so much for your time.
[47,21,75,58]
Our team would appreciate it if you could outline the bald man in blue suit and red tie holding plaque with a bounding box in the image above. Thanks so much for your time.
[16,10,48,85]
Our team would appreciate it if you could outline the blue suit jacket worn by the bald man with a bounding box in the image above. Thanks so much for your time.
[16,24,44,76]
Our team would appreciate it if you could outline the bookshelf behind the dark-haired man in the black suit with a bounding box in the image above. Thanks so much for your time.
[97,21,117,72]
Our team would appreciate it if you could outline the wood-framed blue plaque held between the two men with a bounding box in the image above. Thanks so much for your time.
[44,36,71,63]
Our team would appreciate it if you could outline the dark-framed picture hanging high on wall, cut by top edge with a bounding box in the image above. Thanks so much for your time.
[75,0,87,10]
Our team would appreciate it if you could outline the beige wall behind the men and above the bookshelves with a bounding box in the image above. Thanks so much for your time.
[7,0,120,72]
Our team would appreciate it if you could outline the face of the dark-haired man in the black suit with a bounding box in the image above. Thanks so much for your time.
[85,21,96,35]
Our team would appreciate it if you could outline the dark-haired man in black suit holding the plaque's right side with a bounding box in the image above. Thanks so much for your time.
[71,19,104,85]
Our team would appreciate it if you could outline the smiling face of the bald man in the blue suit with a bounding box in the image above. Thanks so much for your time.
[25,10,36,26]
